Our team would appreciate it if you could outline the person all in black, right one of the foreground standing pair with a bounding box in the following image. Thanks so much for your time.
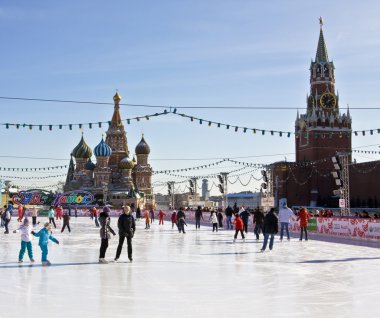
[115,206,136,262]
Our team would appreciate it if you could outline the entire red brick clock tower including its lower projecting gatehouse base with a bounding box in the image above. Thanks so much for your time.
[273,18,351,206]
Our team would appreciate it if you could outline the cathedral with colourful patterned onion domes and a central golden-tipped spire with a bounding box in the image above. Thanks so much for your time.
[64,92,154,207]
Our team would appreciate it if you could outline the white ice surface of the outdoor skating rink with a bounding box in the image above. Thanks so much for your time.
[0,217,380,318]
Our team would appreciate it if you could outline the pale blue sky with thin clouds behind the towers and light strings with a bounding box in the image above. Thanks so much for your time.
[0,0,380,194]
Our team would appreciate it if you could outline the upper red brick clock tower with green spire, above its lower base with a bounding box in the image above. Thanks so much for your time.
[295,18,351,162]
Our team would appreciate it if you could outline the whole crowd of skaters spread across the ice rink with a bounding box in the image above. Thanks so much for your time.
[0,203,377,265]
